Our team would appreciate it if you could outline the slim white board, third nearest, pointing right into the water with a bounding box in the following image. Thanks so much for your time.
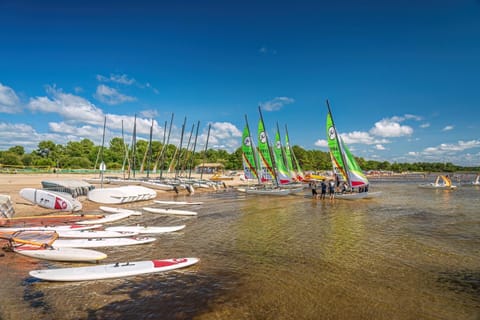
[52,237,156,248]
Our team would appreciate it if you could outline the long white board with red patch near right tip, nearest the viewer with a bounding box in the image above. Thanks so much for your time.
[30,258,199,281]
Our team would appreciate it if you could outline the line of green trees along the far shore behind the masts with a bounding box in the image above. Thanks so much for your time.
[0,138,480,172]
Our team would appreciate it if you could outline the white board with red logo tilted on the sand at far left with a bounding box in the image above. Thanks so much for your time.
[19,188,82,211]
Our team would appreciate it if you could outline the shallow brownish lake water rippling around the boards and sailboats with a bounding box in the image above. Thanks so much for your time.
[0,181,480,320]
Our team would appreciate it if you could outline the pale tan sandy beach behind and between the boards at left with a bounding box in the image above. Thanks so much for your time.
[0,173,241,217]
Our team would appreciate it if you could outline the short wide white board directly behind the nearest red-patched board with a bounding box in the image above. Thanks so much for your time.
[13,245,107,262]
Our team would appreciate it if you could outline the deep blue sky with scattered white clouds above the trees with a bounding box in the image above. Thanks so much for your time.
[0,0,480,166]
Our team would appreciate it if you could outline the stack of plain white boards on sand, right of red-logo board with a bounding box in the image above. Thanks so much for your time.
[87,186,157,204]
